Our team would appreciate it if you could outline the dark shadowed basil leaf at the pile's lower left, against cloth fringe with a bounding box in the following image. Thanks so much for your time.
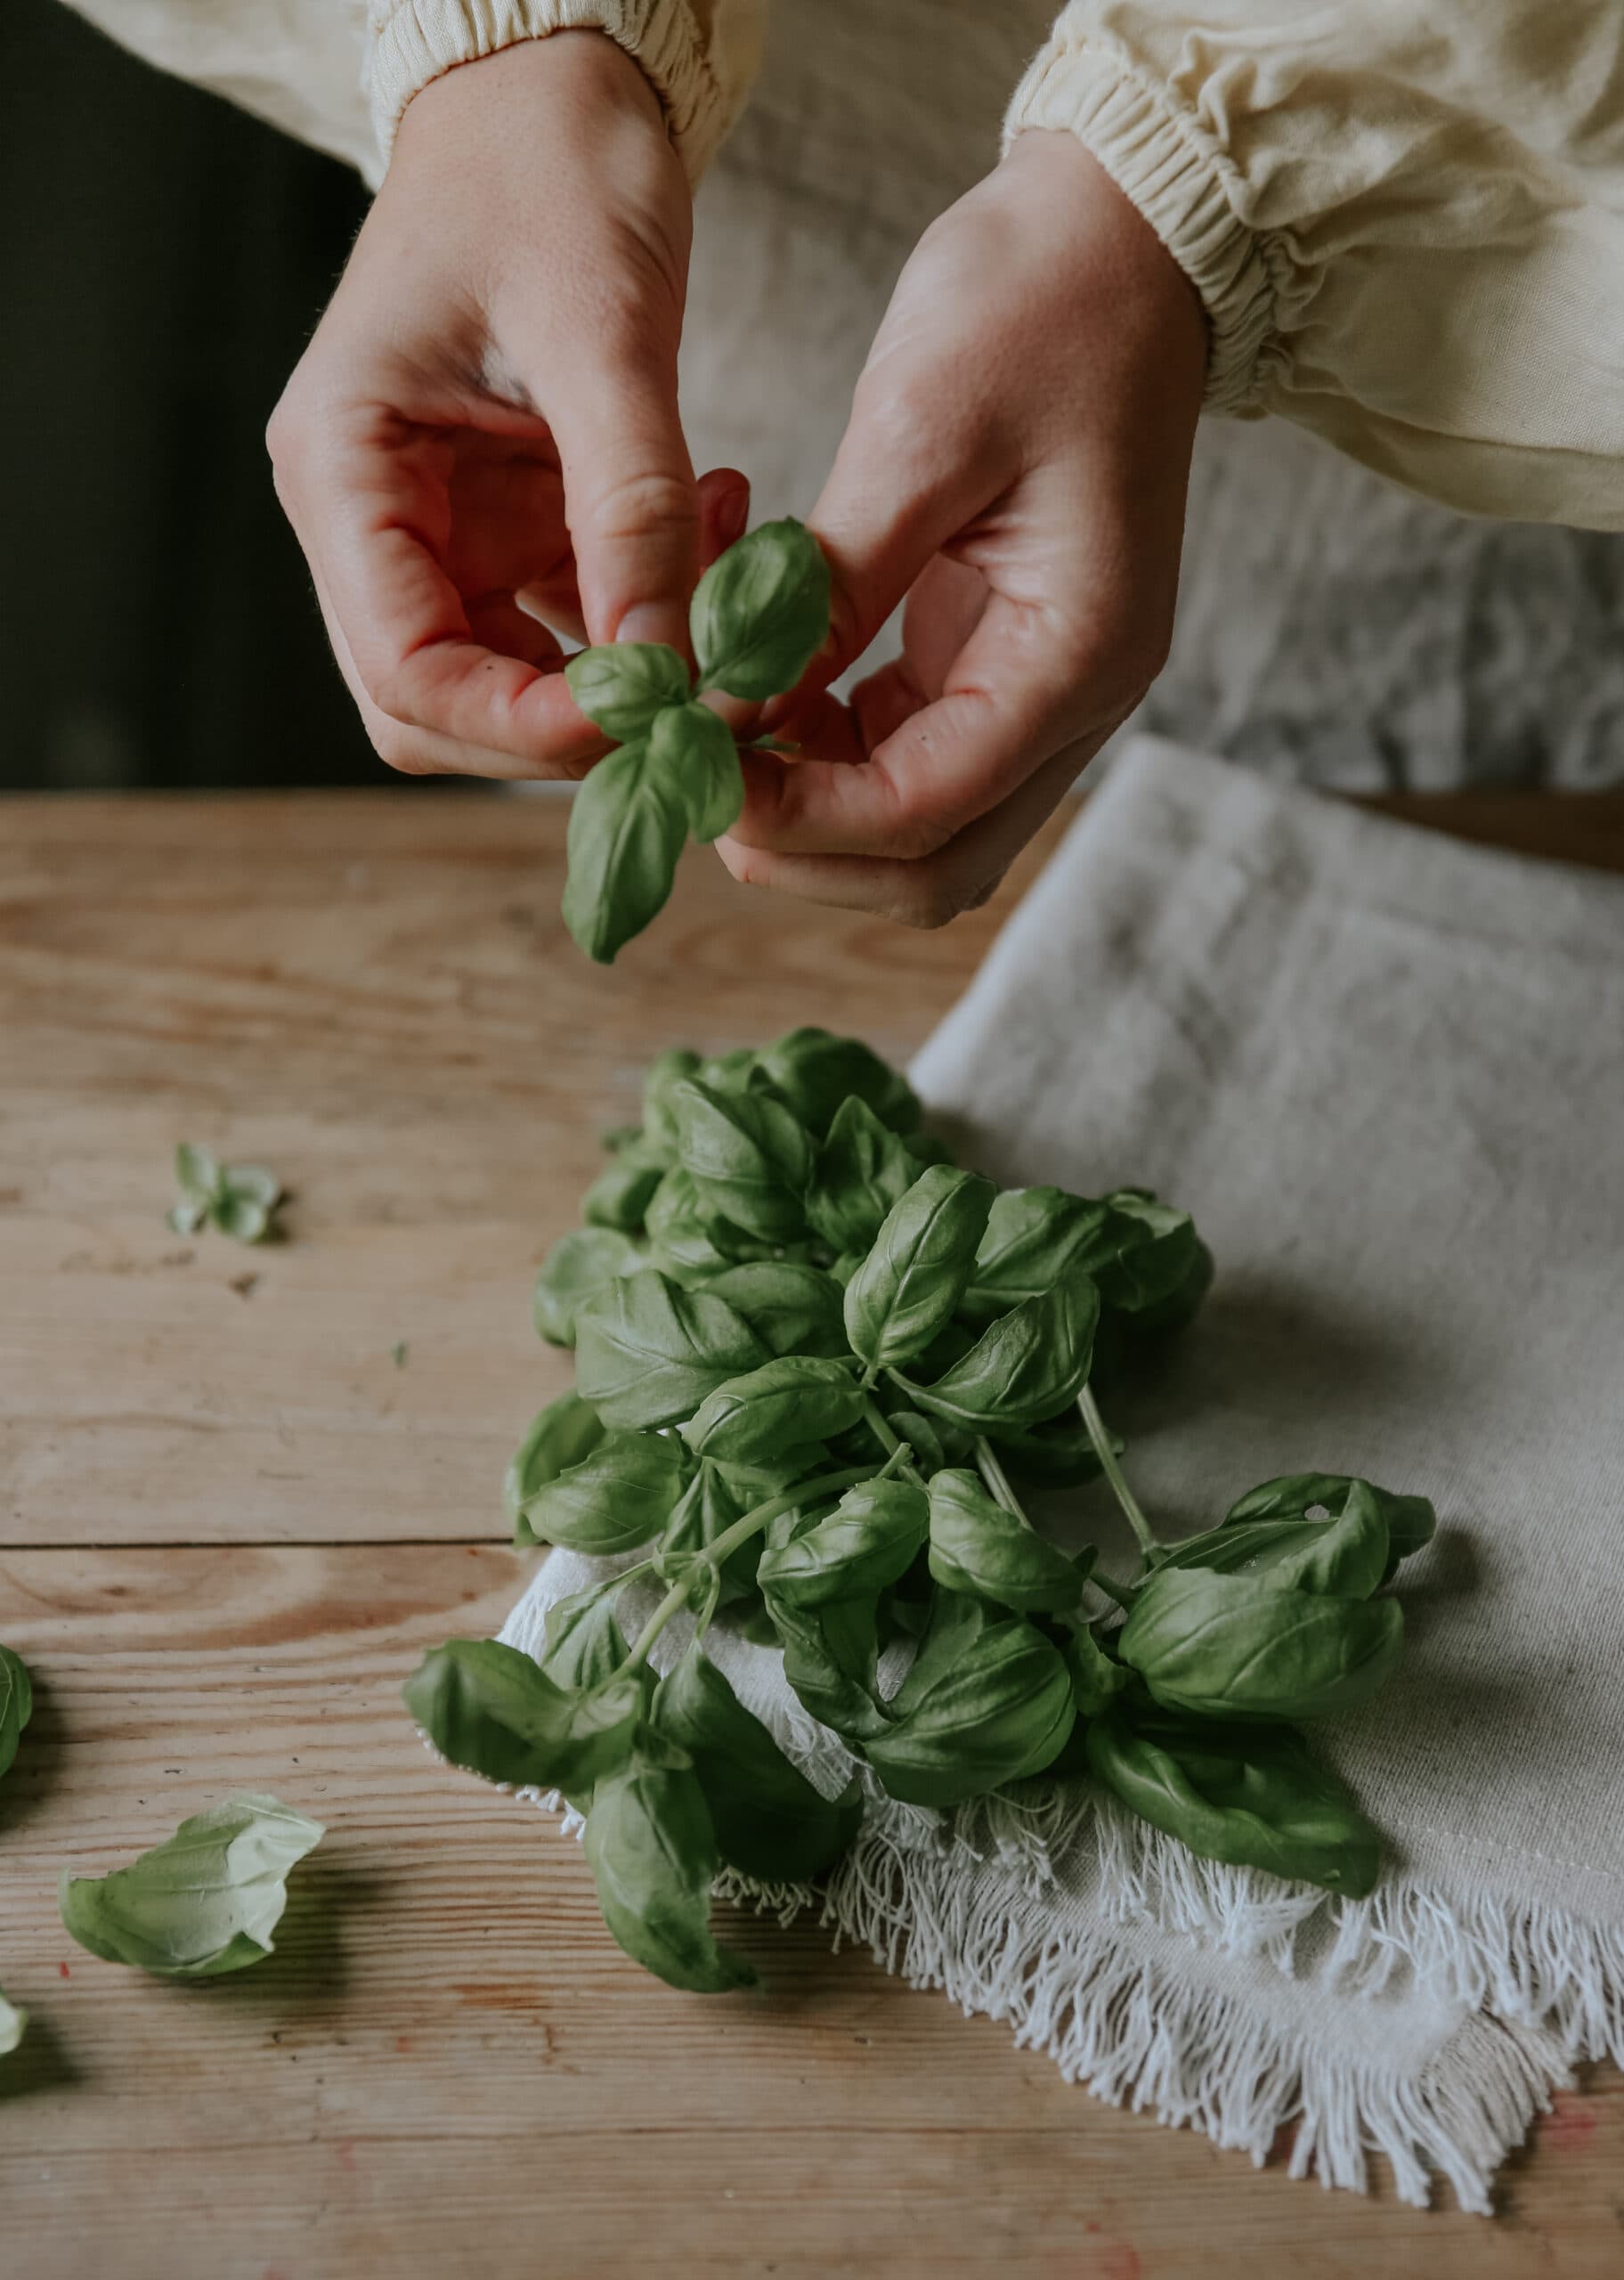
[650,1646,862,1884]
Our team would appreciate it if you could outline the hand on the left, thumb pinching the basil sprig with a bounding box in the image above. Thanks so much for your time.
[267,32,748,778]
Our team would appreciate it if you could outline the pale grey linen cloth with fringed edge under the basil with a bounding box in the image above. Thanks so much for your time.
[504,738,1624,2210]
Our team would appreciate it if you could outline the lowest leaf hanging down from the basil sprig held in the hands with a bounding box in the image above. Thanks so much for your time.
[564,741,689,966]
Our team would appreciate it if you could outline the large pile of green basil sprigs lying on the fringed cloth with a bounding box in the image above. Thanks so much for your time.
[406,1029,1433,1988]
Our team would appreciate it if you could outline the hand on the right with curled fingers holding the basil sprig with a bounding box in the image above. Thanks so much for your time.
[719,130,1206,925]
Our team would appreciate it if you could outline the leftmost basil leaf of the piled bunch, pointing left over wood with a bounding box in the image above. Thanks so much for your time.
[402,1640,648,1795]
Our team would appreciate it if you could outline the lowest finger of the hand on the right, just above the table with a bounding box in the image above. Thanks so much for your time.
[716,744,1092,928]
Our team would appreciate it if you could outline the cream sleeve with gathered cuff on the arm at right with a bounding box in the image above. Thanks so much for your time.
[1006,0,1624,529]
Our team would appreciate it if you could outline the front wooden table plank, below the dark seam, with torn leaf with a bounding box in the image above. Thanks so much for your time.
[0,1546,1624,2280]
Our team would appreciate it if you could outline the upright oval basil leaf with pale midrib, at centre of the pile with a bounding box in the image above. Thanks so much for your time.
[846,1165,994,1358]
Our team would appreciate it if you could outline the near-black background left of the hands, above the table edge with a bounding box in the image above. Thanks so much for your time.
[0,0,374,791]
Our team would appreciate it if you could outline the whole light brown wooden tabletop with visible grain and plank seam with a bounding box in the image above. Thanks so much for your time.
[0,794,1624,2280]
